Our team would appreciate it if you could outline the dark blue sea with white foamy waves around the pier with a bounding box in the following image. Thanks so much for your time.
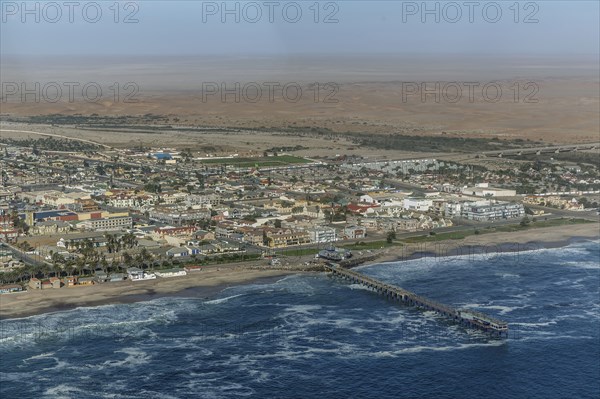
[0,242,600,399]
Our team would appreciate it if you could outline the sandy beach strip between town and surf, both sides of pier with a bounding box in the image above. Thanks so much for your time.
[0,223,600,321]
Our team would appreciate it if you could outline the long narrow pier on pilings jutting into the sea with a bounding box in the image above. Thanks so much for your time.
[325,263,508,337]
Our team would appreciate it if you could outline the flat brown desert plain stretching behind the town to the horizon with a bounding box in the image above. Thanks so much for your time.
[2,57,600,147]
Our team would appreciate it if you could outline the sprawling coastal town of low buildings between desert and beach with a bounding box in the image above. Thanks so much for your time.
[0,125,600,293]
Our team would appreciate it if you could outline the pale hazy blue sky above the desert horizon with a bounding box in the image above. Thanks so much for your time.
[0,0,600,56]
